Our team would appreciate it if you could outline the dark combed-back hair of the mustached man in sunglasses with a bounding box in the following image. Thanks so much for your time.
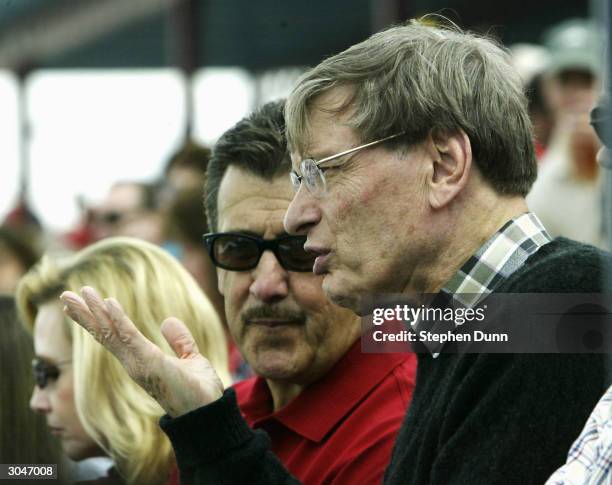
[205,100,291,231]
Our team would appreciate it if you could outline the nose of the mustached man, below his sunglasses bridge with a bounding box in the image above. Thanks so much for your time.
[249,250,289,303]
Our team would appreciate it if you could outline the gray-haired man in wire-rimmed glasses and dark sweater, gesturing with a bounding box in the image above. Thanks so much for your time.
[62,22,605,485]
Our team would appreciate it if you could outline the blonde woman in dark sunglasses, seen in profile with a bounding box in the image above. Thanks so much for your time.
[17,238,230,485]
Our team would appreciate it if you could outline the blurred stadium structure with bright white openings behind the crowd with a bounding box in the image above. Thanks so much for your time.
[0,0,600,232]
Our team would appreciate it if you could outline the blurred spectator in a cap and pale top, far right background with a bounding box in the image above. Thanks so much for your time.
[527,19,606,248]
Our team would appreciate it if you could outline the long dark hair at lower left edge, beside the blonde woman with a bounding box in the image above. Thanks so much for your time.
[0,295,60,464]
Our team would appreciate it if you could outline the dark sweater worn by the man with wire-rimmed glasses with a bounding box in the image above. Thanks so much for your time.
[161,238,606,485]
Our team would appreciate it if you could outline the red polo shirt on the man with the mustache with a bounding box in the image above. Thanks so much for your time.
[234,341,416,485]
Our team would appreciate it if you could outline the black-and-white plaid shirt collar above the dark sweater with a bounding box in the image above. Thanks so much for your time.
[426,212,552,358]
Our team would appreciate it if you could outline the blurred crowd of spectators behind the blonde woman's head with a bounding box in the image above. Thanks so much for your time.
[0,140,250,377]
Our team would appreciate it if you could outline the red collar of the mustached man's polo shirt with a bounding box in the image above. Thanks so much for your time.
[240,340,406,443]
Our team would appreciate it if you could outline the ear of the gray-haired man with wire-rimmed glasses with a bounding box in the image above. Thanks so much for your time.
[428,130,472,209]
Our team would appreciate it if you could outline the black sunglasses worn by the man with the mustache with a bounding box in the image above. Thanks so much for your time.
[203,232,316,272]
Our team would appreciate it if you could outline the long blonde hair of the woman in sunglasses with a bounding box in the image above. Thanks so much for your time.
[17,238,231,484]
